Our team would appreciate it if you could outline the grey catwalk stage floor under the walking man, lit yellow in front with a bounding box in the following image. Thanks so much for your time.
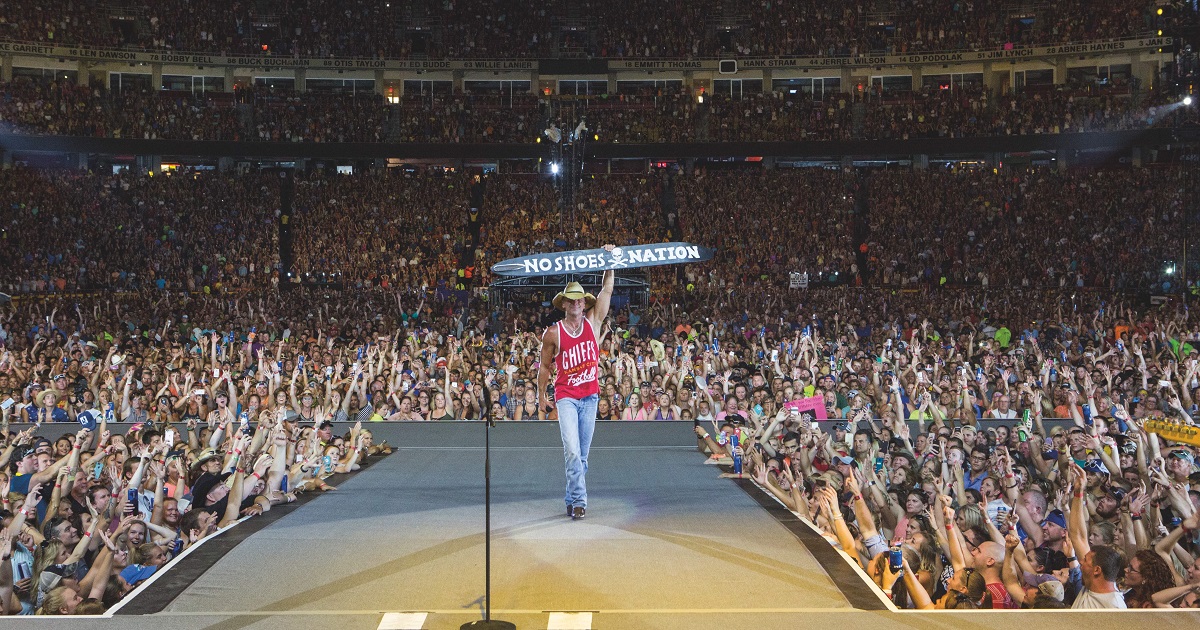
[43,422,1200,630]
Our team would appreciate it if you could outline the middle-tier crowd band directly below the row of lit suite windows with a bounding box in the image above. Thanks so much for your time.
[0,79,1198,144]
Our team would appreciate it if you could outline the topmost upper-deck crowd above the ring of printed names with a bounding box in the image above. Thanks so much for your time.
[0,0,1159,58]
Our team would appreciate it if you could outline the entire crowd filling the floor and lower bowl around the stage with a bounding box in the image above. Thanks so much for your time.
[0,159,1200,614]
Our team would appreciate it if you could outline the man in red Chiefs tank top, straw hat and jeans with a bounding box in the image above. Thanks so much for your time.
[538,245,613,521]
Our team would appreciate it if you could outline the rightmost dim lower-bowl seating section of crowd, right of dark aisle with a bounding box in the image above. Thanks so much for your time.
[868,168,1193,292]
